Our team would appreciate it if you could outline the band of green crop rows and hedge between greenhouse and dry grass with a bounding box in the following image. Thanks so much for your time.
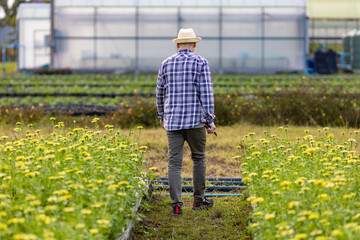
[0,75,360,127]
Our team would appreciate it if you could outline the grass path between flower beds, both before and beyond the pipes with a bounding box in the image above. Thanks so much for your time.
[129,125,355,240]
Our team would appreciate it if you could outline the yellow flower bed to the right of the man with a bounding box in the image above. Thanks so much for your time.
[236,127,360,240]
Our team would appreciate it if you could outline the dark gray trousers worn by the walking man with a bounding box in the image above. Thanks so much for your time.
[166,127,206,206]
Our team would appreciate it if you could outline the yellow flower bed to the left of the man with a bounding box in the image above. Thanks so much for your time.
[0,118,149,240]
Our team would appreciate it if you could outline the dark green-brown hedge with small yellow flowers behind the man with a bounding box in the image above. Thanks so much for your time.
[0,88,360,127]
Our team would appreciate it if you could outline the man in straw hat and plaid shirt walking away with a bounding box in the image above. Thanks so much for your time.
[156,28,216,216]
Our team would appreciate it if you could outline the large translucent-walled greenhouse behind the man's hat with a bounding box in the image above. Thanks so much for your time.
[19,0,307,73]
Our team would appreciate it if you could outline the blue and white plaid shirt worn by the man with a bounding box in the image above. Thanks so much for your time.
[156,49,215,131]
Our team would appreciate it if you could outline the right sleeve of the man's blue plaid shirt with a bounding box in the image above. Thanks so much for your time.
[199,61,215,125]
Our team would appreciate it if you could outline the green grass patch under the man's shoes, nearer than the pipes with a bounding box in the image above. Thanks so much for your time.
[134,196,252,240]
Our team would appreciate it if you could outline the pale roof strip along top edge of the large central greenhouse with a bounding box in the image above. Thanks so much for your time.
[55,0,306,7]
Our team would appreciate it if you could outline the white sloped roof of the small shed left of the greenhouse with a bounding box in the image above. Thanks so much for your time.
[16,3,50,19]
